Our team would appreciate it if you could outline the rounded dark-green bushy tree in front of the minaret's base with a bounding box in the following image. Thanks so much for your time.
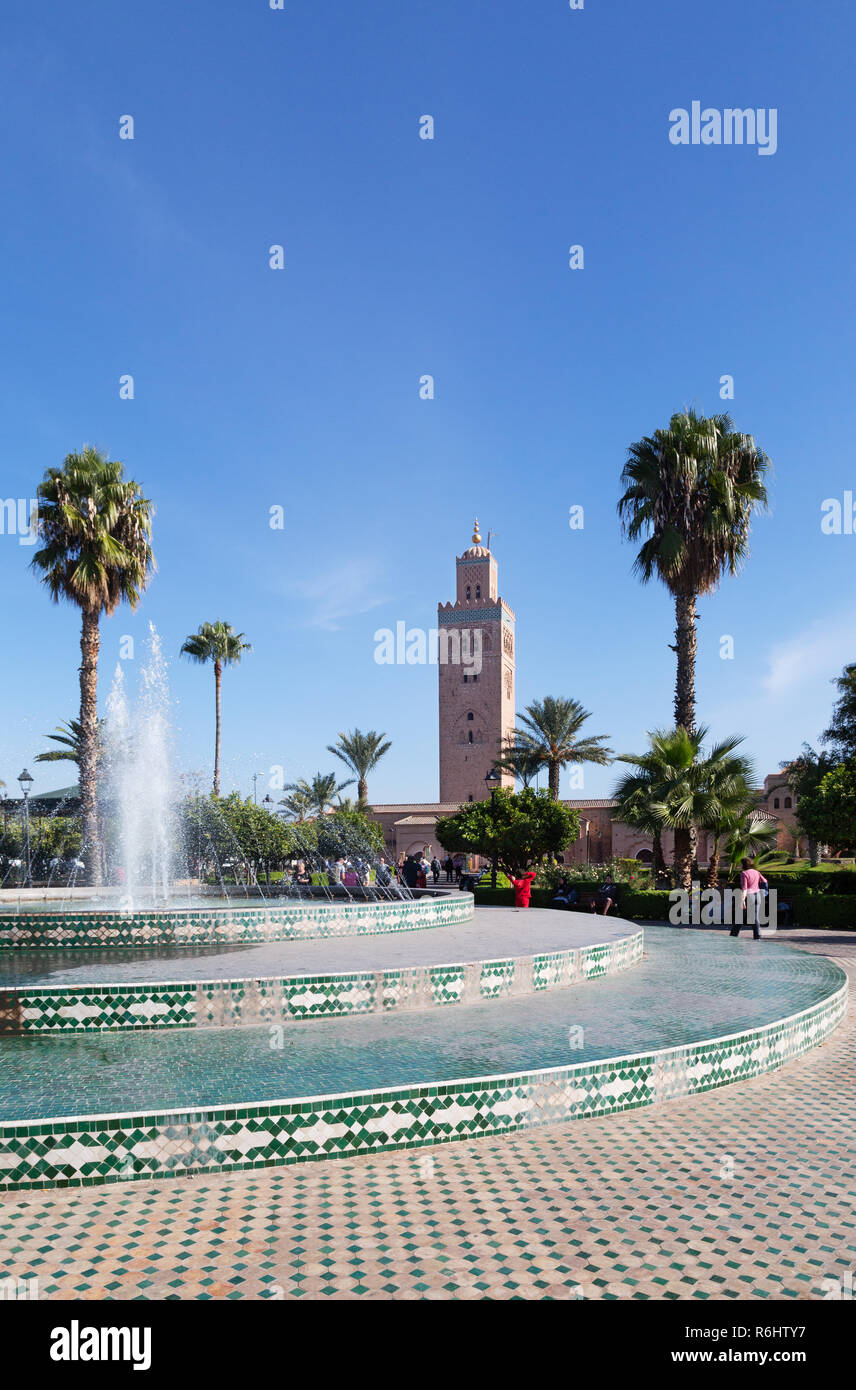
[435,787,579,877]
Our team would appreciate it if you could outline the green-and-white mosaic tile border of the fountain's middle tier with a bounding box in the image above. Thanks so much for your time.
[0,929,645,1036]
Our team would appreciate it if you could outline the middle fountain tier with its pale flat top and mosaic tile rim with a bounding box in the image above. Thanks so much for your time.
[0,908,643,1034]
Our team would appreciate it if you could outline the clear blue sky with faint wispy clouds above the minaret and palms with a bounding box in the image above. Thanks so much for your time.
[0,0,856,801]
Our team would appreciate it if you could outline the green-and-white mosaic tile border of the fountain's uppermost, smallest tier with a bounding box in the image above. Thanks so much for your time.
[0,892,475,951]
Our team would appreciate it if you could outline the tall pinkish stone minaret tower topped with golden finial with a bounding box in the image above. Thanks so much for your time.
[438,517,514,803]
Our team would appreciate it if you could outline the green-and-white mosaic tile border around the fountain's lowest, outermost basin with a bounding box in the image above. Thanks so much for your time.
[0,972,848,1191]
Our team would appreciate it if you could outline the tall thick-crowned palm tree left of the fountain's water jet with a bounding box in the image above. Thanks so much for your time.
[32,445,154,887]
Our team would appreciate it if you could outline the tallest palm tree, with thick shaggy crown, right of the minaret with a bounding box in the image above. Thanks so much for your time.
[618,410,770,734]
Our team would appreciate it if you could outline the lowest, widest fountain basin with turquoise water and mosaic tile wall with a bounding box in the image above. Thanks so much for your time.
[0,927,848,1190]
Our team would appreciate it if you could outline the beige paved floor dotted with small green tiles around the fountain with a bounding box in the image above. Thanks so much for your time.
[0,933,856,1300]
